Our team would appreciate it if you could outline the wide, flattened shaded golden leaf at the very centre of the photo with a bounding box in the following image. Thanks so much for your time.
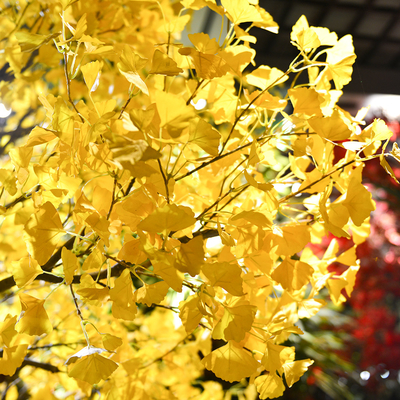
[138,204,196,234]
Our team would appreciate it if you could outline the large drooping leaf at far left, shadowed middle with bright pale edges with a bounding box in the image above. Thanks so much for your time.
[24,202,65,265]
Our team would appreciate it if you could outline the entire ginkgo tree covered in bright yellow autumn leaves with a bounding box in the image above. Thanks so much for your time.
[0,0,400,400]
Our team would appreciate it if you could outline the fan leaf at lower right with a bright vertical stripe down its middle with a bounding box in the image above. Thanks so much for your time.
[271,257,314,291]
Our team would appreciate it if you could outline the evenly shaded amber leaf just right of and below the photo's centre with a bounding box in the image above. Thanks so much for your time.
[202,262,243,296]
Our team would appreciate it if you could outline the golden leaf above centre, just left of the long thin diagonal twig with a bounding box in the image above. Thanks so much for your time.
[189,118,221,156]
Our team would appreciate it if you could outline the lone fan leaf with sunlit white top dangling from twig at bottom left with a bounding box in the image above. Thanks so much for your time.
[68,352,118,385]
